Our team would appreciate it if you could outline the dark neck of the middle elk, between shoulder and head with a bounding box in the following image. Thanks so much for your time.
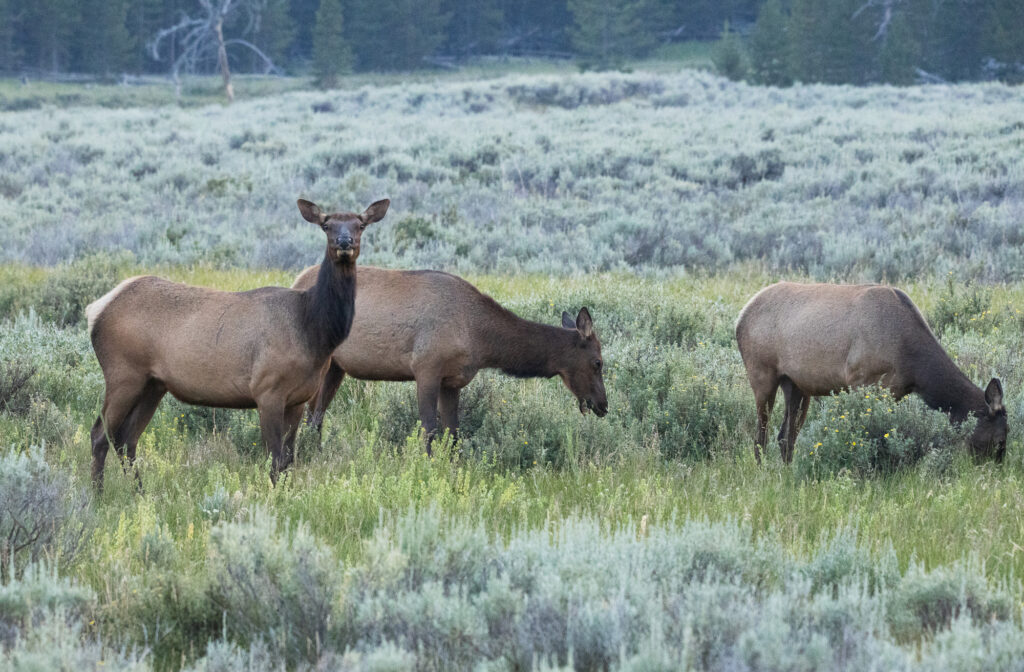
[484,297,577,378]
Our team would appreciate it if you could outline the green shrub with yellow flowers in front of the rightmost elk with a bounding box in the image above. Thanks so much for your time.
[796,387,973,478]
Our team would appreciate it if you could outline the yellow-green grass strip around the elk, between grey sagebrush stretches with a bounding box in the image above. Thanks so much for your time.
[0,265,1024,668]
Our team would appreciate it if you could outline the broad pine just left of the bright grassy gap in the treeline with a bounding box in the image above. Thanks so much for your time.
[568,0,653,70]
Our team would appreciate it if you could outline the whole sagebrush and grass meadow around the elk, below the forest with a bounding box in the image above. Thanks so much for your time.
[0,72,1024,670]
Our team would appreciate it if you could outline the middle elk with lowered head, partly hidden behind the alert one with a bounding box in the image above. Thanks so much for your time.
[292,266,608,452]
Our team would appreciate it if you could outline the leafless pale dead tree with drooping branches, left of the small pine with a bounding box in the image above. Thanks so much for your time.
[148,0,280,102]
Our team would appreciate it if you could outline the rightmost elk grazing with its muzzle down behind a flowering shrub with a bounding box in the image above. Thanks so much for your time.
[736,283,1007,463]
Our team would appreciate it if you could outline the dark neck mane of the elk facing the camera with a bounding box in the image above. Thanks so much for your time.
[303,255,355,360]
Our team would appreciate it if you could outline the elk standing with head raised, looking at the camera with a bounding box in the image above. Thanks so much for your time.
[86,200,389,491]
